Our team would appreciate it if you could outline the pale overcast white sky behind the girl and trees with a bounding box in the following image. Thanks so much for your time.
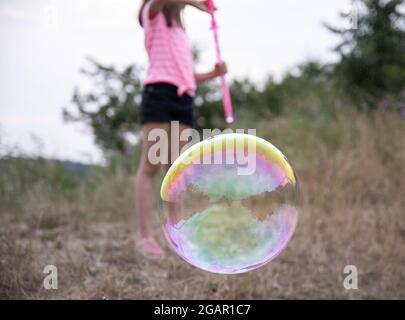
[0,0,351,163]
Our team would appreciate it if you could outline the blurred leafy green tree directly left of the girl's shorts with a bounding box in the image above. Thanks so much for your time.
[63,59,142,156]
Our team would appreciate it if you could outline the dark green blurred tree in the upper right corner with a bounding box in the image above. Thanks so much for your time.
[327,0,405,108]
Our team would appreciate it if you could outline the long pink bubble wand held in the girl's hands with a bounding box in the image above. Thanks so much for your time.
[207,0,233,123]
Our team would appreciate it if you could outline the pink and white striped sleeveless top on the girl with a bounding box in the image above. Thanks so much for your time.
[142,2,196,96]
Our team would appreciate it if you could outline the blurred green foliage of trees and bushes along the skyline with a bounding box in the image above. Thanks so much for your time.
[64,0,405,156]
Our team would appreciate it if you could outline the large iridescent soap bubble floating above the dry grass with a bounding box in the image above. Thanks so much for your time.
[161,134,298,274]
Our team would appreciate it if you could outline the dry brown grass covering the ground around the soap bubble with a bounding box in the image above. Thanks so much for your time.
[0,115,405,299]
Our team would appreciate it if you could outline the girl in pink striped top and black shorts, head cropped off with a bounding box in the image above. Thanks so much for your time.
[135,0,227,258]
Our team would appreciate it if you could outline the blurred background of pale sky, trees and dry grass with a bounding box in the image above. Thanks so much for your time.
[0,0,405,299]
